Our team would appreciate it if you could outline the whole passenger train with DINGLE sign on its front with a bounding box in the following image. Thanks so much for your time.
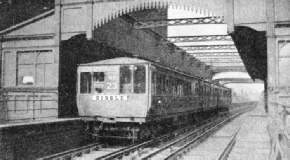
[77,57,231,141]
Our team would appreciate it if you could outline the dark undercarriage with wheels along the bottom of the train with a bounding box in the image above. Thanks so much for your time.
[87,107,228,143]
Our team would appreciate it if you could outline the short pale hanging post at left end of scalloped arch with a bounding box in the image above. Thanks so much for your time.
[86,0,94,40]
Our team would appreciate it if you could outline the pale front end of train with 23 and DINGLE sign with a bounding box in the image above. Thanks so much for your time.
[77,58,149,141]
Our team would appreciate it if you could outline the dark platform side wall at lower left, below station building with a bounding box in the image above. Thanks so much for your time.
[0,119,91,160]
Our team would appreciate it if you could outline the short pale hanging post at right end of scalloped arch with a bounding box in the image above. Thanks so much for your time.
[225,0,235,34]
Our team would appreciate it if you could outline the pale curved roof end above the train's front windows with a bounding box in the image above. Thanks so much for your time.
[79,57,151,66]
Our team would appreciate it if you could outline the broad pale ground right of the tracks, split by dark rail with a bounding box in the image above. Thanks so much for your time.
[184,101,271,160]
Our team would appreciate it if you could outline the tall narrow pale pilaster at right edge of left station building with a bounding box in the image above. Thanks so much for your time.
[54,0,62,117]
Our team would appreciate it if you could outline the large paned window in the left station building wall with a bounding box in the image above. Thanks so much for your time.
[17,51,55,86]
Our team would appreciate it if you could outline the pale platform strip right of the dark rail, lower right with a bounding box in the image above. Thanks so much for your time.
[228,104,271,160]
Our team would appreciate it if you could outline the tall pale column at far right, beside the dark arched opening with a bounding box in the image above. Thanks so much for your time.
[265,0,277,118]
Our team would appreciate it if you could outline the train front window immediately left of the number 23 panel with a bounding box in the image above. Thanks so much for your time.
[93,72,105,93]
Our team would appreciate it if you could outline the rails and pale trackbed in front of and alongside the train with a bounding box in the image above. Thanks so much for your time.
[40,107,251,160]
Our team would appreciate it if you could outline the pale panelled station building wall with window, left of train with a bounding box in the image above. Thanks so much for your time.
[0,12,58,123]
